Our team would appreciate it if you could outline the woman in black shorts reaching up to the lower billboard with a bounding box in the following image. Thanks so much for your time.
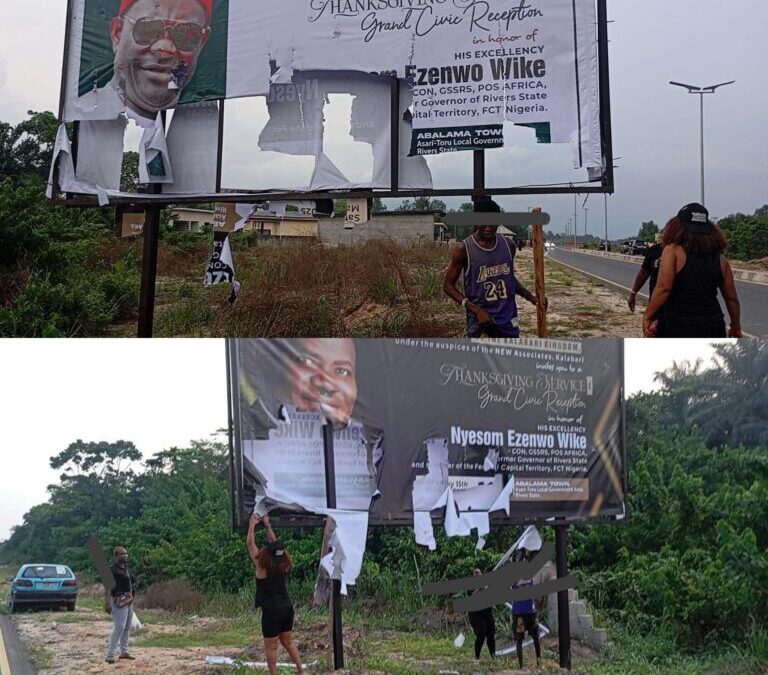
[247,514,306,675]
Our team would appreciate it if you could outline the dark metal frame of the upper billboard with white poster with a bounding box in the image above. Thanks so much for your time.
[53,0,614,207]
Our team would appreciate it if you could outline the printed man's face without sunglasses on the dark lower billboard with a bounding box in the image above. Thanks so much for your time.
[291,338,357,424]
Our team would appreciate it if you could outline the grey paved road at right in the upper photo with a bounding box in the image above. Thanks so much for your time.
[547,247,768,336]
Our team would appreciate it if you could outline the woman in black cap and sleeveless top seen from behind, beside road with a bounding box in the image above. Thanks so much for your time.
[643,203,742,338]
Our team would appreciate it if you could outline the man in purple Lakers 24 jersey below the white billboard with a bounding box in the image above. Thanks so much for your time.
[443,197,546,338]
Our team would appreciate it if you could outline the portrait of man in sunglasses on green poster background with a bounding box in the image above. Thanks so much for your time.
[65,0,222,126]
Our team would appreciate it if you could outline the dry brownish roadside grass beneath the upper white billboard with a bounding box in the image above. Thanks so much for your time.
[130,237,636,337]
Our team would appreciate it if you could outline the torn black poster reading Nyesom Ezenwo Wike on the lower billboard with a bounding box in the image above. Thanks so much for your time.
[228,338,624,532]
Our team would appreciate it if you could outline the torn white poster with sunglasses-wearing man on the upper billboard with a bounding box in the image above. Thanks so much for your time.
[64,0,601,167]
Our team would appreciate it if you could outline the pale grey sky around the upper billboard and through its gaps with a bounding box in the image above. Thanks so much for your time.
[0,0,768,239]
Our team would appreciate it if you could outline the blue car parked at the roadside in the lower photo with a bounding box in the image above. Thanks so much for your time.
[8,563,78,613]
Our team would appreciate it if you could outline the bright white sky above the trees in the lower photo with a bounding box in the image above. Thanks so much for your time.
[0,339,732,541]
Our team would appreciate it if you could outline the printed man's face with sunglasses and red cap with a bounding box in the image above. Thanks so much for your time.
[111,0,210,117]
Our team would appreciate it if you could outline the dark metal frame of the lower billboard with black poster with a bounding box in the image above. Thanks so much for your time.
[225,338,628,533]
